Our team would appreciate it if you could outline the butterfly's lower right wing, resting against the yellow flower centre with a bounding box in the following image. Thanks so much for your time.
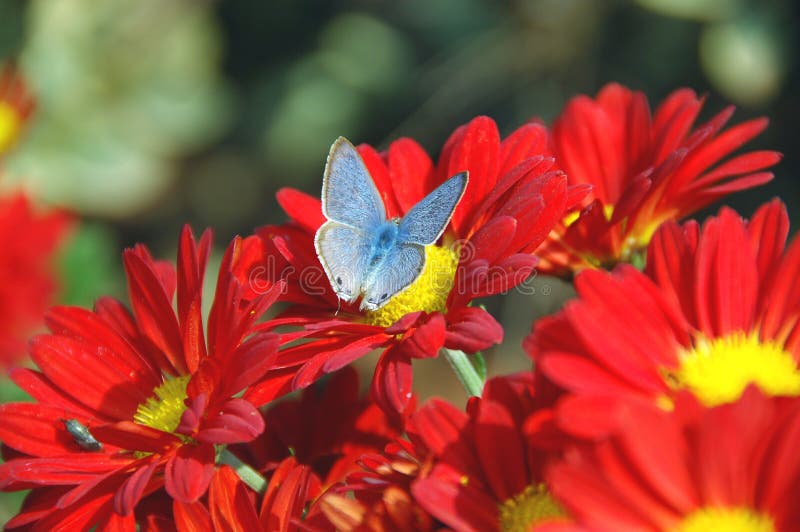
[361,242,425,310]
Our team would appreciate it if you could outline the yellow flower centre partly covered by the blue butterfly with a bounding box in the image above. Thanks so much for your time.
[366,245,458,327]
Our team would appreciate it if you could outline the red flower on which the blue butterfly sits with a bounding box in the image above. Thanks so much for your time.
[250,117,585,412]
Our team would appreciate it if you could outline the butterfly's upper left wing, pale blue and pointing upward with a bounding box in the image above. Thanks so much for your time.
[322,137,386,229]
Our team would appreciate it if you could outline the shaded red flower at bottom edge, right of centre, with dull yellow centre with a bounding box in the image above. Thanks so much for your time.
[409,373,566,531]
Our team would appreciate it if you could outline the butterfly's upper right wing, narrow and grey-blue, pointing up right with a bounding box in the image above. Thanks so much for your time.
[399,172,468,246]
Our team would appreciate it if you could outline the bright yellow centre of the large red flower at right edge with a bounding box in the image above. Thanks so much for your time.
[665,332,800,406]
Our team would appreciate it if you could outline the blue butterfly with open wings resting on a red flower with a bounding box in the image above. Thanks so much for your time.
[314,137,468,310]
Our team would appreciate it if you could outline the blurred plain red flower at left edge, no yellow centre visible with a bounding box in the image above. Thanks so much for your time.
[0,193,72,368]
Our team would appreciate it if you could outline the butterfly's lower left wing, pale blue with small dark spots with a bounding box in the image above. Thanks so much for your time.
[314,221,372,303]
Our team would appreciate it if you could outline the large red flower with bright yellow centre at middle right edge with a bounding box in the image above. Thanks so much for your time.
[525,200,800,436]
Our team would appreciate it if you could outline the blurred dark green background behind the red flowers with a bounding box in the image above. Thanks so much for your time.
[0,0,800,523]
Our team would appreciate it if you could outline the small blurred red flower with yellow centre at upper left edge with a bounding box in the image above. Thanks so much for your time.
[0,63,36,157]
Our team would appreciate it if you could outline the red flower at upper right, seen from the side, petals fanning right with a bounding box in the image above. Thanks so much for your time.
[539,84,781,276]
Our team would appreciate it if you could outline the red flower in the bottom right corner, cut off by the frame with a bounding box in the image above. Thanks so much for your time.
[546,387,800,532]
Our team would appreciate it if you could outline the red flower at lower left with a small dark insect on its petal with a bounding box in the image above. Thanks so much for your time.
[0,227,280,529]
